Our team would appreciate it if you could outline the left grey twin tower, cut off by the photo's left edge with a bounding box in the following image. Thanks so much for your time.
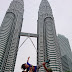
[0,0,24,72]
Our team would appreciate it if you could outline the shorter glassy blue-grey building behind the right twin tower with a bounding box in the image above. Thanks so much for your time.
[58,34,72,72]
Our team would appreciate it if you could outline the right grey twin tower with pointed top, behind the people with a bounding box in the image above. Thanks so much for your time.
[37,0,62,72]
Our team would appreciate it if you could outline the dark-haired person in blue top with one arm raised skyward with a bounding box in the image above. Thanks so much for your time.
[21,57,47,72]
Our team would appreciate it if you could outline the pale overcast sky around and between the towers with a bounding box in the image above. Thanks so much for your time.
[0,0,72,72]
